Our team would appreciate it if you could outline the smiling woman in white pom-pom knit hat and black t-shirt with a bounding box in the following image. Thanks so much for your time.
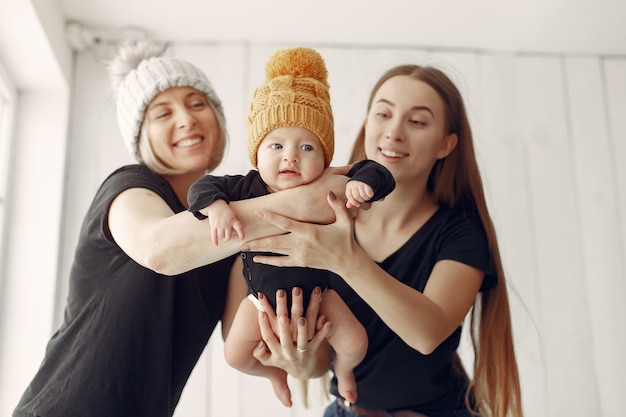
[13,43,346,417]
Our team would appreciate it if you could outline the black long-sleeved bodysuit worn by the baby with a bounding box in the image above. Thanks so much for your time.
[187,160,396,309]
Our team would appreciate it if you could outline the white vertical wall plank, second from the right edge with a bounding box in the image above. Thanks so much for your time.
[566,57,626,417]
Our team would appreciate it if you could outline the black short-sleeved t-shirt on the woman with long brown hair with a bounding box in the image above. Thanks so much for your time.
[331,207,496,412]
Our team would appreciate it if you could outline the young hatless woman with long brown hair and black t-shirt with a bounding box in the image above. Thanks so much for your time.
[245,65,522,417]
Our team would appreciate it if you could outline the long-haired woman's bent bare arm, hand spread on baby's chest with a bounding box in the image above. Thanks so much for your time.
[239,190,484,354]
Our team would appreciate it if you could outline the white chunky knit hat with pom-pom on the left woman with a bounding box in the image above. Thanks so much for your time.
[109,42,225,161]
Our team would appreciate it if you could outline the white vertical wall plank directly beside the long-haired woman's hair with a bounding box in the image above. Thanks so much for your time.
[470,55,549,416]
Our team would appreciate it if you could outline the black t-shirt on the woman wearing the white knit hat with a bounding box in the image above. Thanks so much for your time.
[14,165,234,417]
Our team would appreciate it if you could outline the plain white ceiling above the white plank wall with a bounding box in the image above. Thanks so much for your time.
[57,0,626,55]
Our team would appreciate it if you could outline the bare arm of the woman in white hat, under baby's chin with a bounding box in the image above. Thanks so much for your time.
[109,167,347,275]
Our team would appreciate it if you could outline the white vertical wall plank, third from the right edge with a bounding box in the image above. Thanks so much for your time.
[510,57,599,417]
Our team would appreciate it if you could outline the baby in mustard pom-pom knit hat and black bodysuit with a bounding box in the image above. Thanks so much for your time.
[188,48,395,405]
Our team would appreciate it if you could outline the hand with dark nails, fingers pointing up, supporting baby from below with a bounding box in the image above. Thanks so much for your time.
[253,288,331,379]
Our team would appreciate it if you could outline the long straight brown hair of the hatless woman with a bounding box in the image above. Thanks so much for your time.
[350,65,523,417]
